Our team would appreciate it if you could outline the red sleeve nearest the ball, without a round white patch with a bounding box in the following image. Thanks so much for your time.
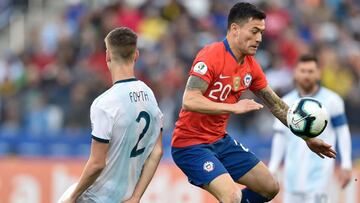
[249,57,268,91]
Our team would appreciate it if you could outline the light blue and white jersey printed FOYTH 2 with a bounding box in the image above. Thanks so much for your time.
[78,78,162,203]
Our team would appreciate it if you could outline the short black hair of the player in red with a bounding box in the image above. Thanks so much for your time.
[227,2,266,29]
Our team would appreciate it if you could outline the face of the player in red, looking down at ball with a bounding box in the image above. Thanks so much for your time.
[235,19,265,55]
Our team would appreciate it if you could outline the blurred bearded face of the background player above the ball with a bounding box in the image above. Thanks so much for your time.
[294,61,320,92]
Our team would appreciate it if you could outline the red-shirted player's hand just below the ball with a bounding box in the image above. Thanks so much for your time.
[305,138,336,159]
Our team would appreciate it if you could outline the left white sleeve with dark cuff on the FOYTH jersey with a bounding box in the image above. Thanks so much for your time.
[90,106,113,143]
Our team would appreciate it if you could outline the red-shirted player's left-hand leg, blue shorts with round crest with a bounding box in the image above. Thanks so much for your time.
[172,145,241,203]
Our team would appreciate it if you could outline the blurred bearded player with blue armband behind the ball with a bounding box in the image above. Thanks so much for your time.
[269,55,351,203]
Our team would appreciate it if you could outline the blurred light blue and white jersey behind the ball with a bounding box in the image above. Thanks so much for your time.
[269,87,351,192]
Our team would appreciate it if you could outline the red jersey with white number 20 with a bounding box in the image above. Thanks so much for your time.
[171,39,267,147]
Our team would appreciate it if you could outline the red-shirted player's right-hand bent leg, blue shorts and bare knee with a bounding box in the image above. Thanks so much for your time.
[218,136,279,202]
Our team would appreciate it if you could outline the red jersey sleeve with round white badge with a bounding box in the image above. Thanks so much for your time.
[189,48,215,84]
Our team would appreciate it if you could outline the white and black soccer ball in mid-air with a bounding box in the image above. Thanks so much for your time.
[287,97,328,138]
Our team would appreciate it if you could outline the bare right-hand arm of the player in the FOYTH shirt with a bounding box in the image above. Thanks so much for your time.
[124,132,163,203]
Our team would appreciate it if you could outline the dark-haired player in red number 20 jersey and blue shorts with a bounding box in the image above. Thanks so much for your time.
[172,3,336,203]
